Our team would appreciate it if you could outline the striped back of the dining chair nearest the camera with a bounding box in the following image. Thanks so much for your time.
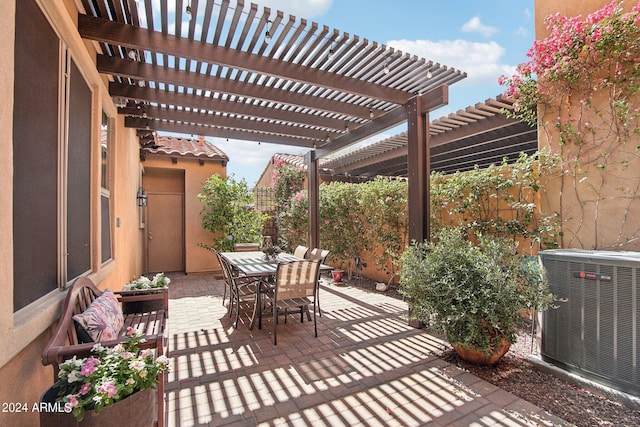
[274,260,320,301]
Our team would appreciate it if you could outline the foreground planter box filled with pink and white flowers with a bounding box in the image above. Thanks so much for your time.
[40,328,169,427]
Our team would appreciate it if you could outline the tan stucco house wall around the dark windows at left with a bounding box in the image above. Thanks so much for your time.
[0,0,142,426]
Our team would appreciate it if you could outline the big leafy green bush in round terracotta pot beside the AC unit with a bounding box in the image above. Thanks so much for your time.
[400,228,554,364]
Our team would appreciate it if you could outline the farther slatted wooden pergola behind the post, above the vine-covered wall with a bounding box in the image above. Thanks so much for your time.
[320,95,538,181]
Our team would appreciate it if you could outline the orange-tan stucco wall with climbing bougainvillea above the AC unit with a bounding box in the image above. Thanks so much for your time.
[535,0,640,251]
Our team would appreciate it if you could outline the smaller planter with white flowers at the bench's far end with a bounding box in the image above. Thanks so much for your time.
[118,273,171,315]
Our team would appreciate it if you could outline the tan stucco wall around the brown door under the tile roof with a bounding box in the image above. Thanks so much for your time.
[143,155,227,273]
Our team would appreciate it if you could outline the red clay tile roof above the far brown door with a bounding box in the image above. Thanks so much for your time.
[142,134,229,161]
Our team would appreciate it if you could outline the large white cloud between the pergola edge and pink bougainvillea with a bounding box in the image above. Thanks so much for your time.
[388,39,515,86]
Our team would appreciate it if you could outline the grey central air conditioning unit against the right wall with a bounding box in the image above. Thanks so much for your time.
[540,249,640,395]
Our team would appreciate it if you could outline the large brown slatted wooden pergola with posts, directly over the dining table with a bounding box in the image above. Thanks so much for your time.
[78,0,466,246]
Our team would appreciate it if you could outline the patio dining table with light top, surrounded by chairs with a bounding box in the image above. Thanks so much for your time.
[220,251,333,329]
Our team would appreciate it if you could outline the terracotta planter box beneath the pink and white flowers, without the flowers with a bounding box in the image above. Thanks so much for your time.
[40,387,158,427]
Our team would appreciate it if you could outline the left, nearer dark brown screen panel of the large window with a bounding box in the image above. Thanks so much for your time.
[13,0,61,311]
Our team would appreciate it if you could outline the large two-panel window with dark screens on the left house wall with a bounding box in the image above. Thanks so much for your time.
[13,0,95,312]
